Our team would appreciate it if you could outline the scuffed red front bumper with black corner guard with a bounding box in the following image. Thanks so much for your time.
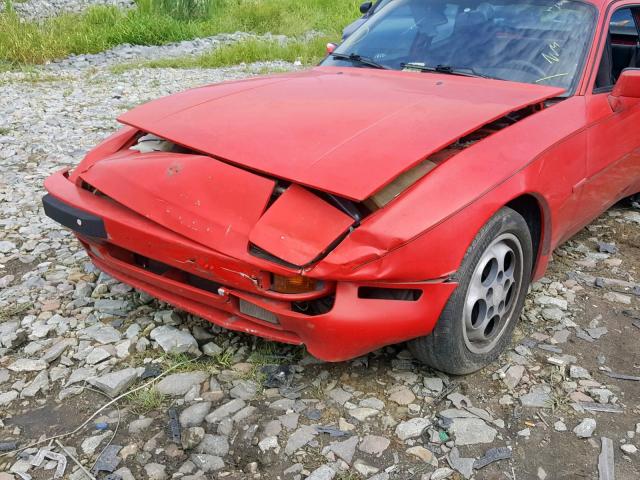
[43,172,457,361]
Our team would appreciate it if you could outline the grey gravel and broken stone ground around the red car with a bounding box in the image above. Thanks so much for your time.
[0,54,640,480]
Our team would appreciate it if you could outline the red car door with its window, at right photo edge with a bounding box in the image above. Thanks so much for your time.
[577,0,640,224]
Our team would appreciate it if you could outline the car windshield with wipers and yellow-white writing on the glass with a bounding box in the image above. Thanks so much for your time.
[322,0,595,90]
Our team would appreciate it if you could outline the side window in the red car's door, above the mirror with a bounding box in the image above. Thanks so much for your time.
[595,7,640,92]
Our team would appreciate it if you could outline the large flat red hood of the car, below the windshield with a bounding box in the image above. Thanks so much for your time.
[119,67,563,200]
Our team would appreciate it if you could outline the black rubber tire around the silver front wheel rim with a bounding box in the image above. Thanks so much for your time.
[409,207,534,375]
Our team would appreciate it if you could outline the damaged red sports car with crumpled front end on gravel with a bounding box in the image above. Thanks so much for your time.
[44,0,640,374]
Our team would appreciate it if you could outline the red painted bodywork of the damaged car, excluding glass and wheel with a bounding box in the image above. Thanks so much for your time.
[45,1,640,360]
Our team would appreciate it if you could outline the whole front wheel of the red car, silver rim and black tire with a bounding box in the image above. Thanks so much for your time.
[409,207,533,375]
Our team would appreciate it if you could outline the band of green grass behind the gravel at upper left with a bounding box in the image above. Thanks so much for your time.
[0,0,360,68]
